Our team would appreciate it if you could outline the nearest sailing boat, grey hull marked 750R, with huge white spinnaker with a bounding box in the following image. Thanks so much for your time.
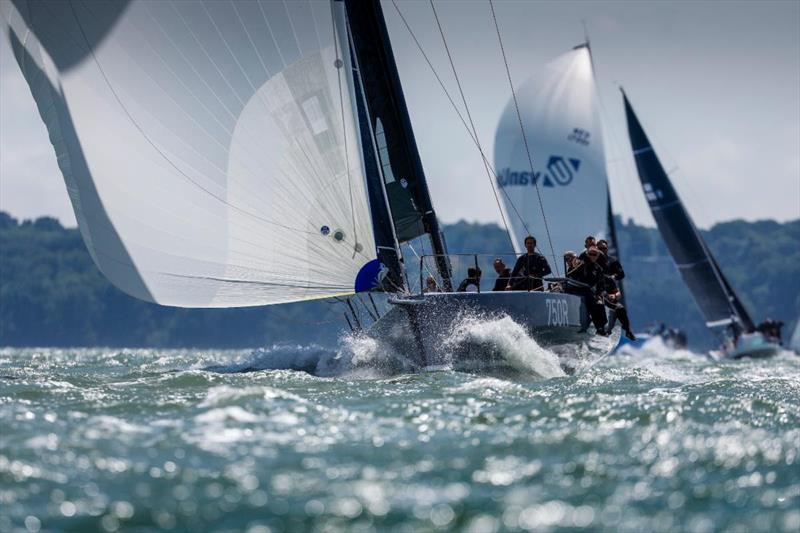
[2,0,604,367]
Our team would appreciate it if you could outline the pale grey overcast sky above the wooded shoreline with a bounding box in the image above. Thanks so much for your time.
[0,0,800,227]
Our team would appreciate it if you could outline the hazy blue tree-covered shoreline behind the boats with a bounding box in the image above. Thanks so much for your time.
[0,212,800,348]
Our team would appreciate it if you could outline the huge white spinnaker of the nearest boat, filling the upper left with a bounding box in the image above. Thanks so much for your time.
[2,0,376,307]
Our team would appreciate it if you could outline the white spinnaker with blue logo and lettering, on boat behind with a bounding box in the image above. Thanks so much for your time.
[494,47,608,260]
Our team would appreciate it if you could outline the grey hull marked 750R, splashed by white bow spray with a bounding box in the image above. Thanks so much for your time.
[366,292,592,372]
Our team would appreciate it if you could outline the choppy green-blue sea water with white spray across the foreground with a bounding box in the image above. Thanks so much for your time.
[0,322,800,532]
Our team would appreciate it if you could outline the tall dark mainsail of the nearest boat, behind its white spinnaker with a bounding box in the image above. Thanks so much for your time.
[338,0,452,291]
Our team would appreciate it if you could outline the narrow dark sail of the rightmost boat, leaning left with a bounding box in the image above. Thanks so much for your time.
[623,92,753,330]
